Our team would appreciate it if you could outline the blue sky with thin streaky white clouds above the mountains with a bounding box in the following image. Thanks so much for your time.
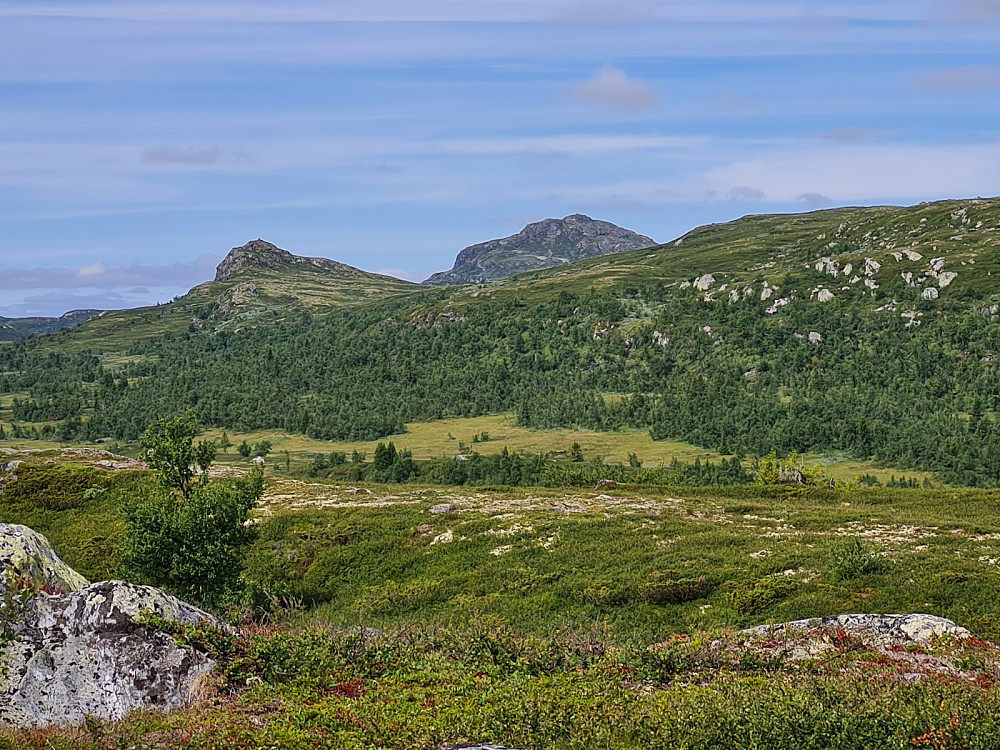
[0,0,1000,317]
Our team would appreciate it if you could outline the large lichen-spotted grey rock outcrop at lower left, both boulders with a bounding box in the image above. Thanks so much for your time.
[0,524,217,727]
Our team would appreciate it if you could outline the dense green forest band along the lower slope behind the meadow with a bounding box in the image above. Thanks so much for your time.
[0,286,1000,486]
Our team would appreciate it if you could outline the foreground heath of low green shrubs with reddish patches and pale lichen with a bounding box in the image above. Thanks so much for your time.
[0,462,1000,750]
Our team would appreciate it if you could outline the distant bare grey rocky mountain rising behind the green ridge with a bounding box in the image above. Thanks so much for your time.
[424,214,656,285]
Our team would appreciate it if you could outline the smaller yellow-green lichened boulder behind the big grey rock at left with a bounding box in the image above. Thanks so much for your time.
[0,523,88,596]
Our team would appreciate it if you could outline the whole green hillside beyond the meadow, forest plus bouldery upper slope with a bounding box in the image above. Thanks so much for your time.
[0,200,1000,486]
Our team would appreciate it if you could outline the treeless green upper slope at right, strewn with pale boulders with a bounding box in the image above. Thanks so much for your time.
[485,199,1000,307]
